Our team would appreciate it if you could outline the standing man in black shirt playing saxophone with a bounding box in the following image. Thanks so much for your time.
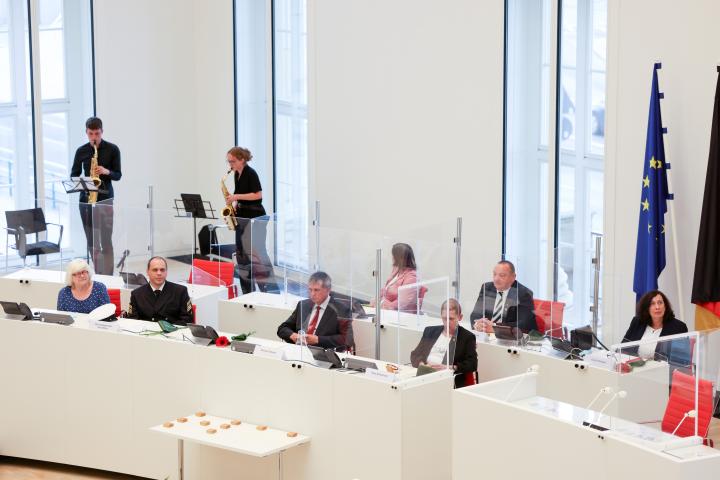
[70,117,122,275]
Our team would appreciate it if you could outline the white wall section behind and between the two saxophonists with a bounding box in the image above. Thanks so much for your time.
[95,0,234,255]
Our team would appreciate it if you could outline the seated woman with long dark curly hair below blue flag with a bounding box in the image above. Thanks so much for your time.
[623,290,690,366]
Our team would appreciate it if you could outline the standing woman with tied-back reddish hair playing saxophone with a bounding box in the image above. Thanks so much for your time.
[223,147,277,293]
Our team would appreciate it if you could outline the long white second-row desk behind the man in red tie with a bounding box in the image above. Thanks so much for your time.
[219,292,669,421]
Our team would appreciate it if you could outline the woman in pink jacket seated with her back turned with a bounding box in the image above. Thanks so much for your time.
[370,243,427,313]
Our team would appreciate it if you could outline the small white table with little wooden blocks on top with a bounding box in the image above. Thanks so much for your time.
[150,412,310,480]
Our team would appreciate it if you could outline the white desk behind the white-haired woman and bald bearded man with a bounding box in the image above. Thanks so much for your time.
[0,268,227,328]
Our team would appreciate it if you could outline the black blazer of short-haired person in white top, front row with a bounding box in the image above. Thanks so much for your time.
[410,325,477,388]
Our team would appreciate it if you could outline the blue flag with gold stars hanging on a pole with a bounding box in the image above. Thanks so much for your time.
[633,63,672,300]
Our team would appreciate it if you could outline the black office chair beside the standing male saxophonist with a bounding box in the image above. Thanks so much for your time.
[5,208,63,270]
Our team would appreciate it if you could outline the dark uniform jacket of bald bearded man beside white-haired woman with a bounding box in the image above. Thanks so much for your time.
[128,282,193,325]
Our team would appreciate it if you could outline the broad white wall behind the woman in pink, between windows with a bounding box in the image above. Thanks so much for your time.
[308,0,503,308]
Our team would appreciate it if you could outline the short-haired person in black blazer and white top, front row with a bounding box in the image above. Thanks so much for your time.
[410,298,477,388]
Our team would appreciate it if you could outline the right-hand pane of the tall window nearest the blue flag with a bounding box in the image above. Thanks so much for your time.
[556,0,607,325]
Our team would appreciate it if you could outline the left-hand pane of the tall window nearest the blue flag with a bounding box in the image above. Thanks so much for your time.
[504,0,552,299]
